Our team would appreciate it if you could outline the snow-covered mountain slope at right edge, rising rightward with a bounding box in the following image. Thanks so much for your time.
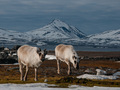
[87,29,120,47]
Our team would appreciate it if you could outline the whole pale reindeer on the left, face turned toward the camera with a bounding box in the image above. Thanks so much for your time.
[17,45,47,81]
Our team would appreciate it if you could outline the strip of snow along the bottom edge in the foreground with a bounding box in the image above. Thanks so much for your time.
[0,83,120,90]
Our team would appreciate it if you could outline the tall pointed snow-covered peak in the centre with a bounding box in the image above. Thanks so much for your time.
[27,19,85,40]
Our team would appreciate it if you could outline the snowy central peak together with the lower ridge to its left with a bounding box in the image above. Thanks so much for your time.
[0,19,86,45]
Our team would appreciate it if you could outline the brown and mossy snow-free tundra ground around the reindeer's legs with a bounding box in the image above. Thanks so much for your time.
[0,51,120,87]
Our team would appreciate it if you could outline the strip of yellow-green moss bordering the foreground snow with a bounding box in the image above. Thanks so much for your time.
[0,76,120,88]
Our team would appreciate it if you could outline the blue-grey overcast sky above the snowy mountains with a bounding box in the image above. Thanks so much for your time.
[0,0,120,34]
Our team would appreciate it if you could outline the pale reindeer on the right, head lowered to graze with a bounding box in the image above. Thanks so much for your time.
[55,44,80,75]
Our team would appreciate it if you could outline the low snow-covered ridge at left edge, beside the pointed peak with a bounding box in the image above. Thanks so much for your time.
[0,28,29,45]
